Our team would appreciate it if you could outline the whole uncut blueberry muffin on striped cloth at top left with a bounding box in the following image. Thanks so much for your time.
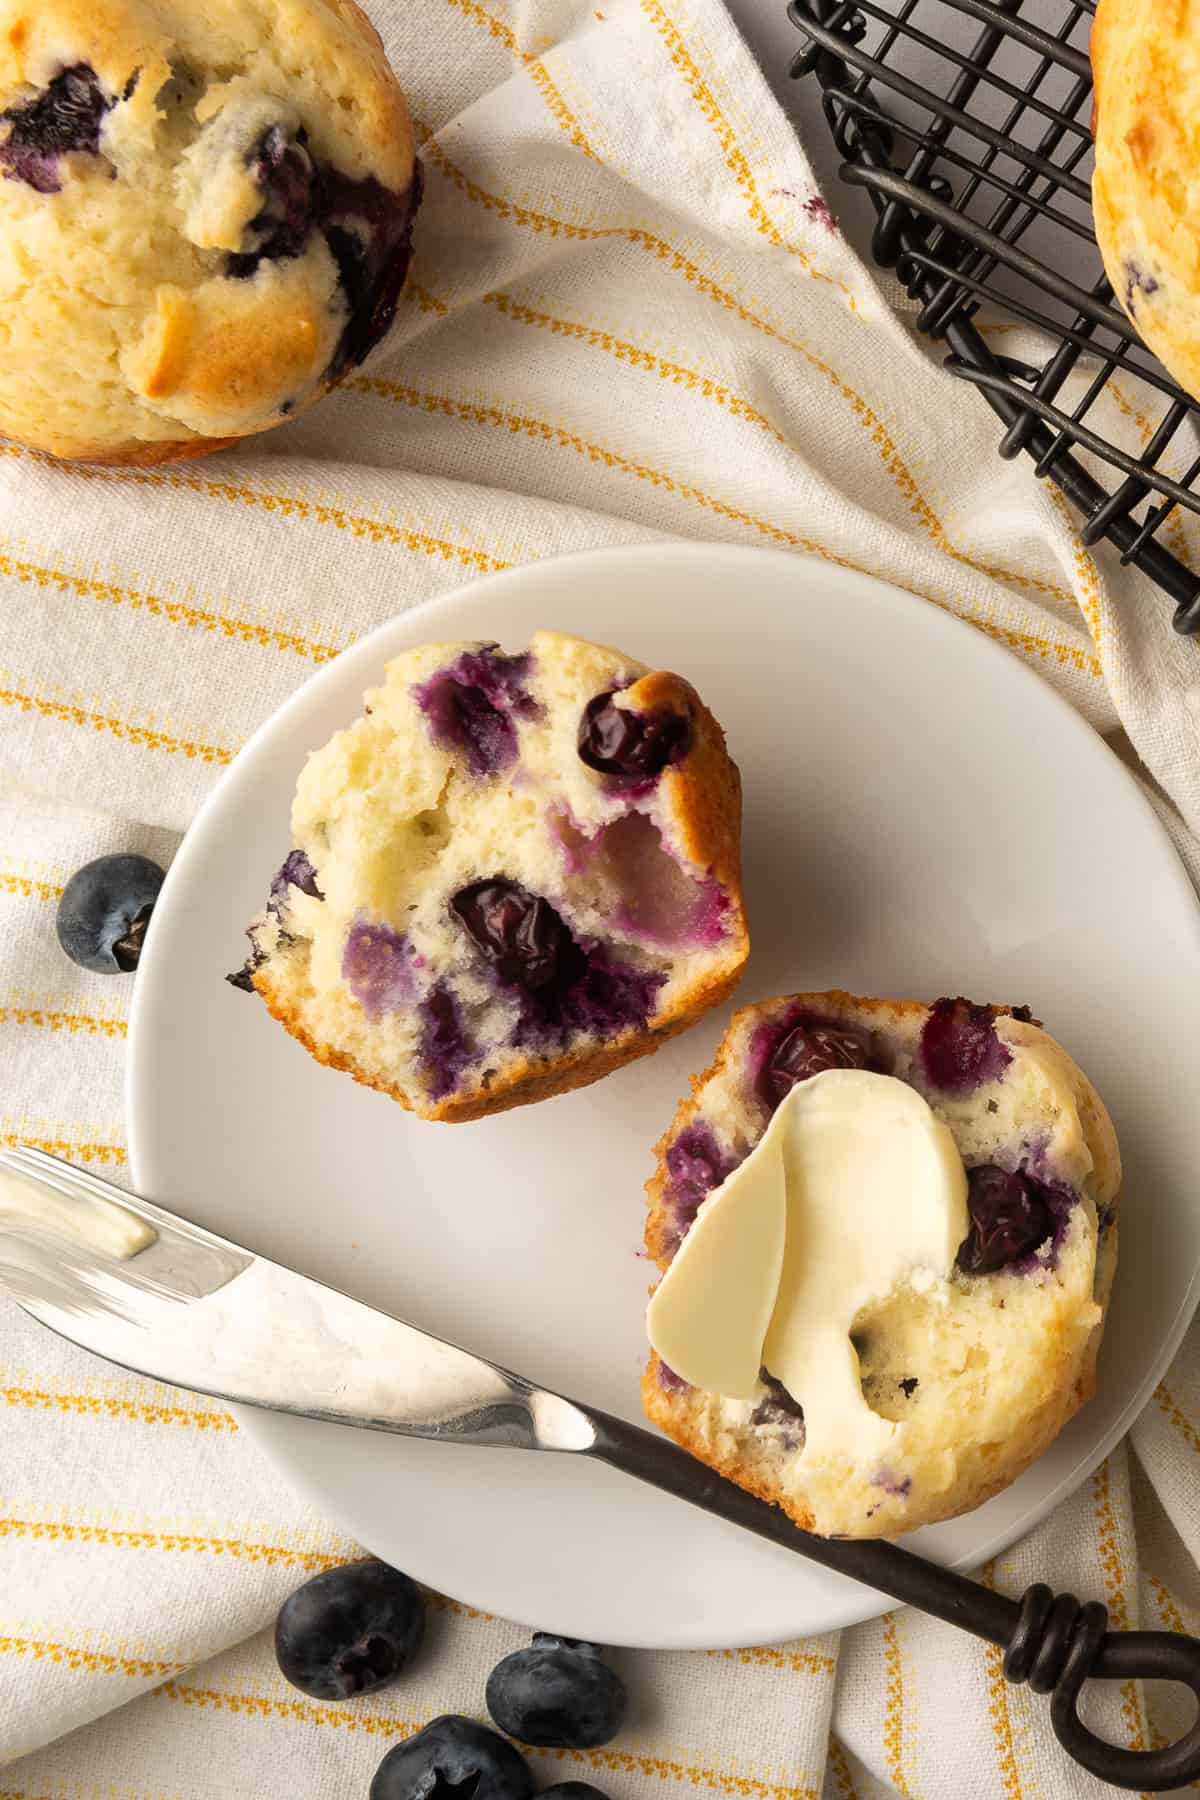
[0,0,421,463]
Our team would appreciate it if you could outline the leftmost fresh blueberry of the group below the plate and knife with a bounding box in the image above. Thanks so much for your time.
[275,1562,425,1699]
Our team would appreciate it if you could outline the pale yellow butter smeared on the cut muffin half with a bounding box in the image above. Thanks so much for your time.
[646,1069,968,1460]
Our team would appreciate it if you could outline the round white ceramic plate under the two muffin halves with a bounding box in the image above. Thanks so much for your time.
[130,545,1200,1647]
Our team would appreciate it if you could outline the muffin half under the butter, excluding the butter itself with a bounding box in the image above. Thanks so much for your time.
[642,992,1121,1537]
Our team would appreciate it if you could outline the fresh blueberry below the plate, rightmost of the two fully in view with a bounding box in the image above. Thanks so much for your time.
[486,1631,626,1750]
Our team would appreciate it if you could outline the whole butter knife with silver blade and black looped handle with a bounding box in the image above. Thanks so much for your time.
[0,1148,1200,1793]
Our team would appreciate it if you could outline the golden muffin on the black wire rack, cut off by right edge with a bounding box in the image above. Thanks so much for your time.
[1092,0,1200,396]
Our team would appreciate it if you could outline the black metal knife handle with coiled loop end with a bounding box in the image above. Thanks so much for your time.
[588,1408,1200,1793]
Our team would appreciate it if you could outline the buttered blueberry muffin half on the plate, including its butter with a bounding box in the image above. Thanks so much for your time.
[642,992,1121,1537]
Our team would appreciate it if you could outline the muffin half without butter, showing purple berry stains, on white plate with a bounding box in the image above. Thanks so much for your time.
[232,632,748,1120]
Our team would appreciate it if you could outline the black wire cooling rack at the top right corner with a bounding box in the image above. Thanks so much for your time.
[788,0,1200,634]
